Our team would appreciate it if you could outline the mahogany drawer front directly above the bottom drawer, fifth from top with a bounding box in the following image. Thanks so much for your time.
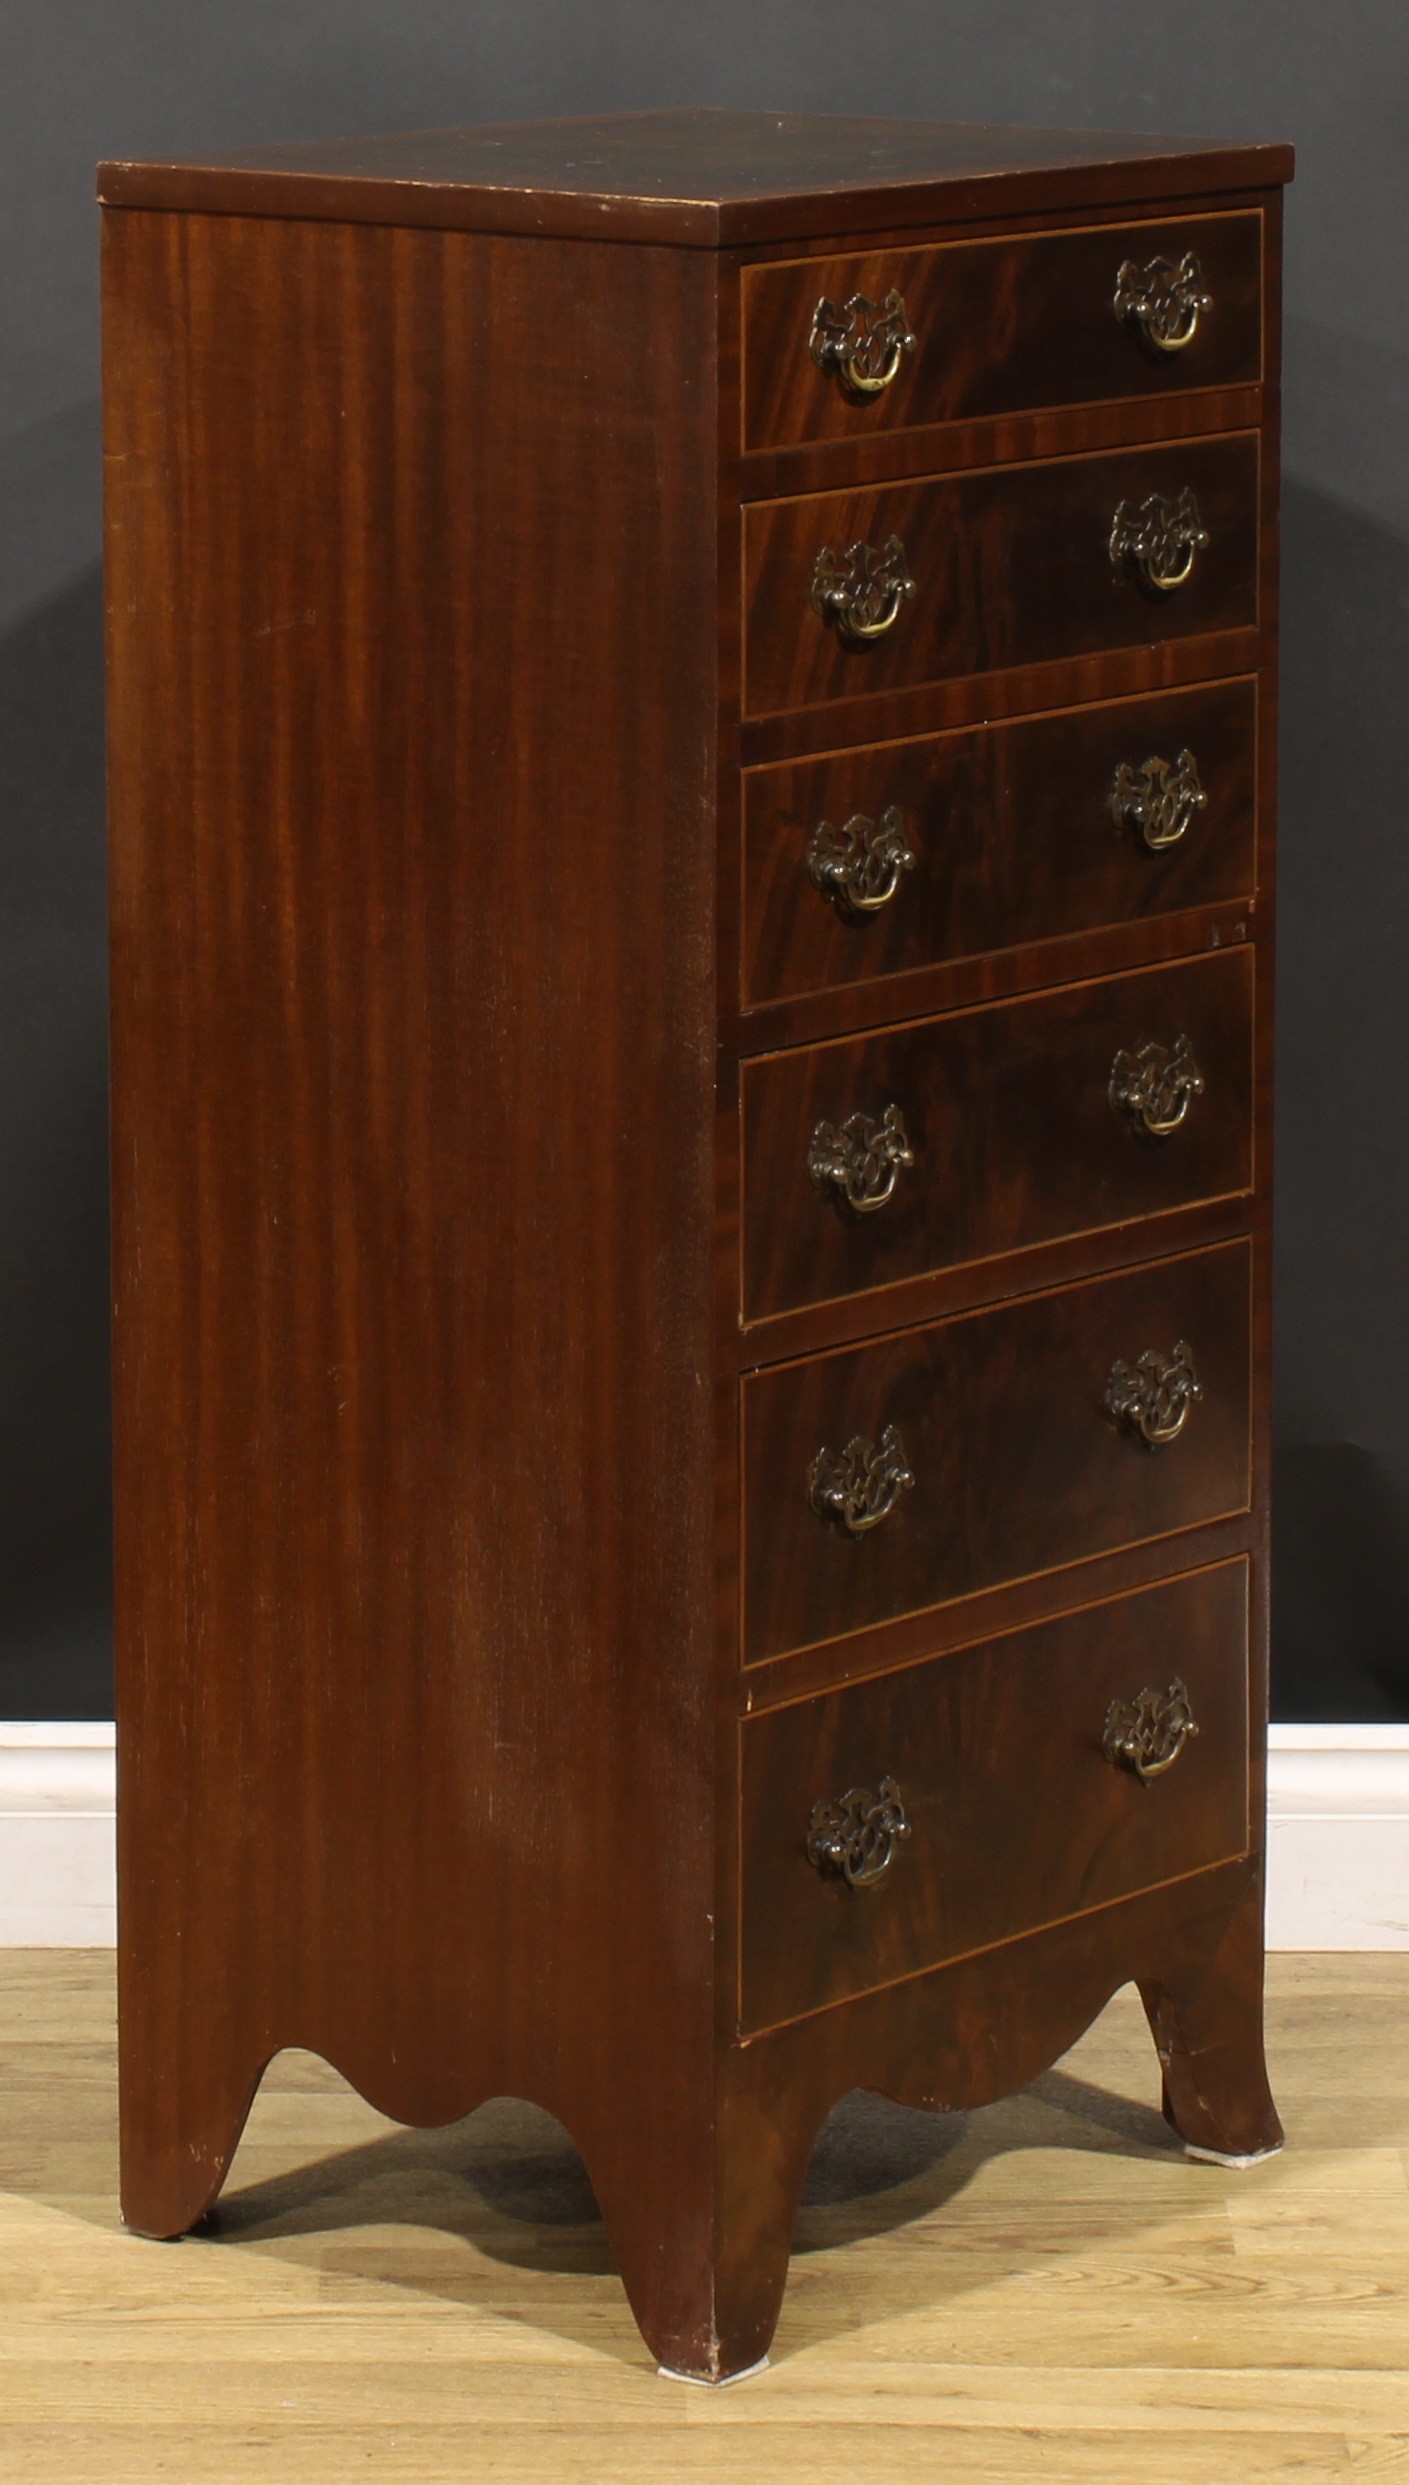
[743,1243,1250,1662]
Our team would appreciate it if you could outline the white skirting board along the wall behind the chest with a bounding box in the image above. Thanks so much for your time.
[0,1725,1409,1951]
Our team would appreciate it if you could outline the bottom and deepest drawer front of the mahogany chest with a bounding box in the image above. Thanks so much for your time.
[741,1561,1247,2028]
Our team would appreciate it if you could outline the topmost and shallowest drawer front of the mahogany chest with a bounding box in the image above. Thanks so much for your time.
[743,209,1262,450]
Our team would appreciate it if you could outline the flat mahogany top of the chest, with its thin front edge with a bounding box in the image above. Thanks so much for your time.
[99,109,1292,249]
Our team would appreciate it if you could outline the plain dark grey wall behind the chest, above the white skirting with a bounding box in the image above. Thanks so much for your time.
[0,0,1409,1717]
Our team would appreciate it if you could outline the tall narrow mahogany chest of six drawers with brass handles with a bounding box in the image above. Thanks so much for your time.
[102,112,1290,2381]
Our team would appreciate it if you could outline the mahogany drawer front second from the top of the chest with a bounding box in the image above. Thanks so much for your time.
[743,432,1257,716]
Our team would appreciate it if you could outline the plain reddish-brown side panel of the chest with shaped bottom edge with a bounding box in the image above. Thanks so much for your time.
[107,211,716,2333]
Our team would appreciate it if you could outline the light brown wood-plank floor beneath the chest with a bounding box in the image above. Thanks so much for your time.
[0,1951,1409,2485]
